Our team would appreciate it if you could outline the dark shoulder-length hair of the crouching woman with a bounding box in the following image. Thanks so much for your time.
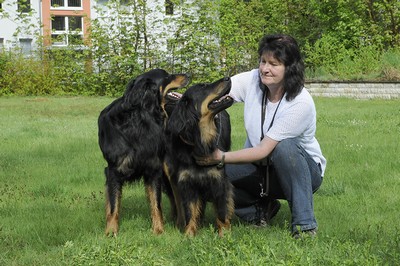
[258,34,304,101]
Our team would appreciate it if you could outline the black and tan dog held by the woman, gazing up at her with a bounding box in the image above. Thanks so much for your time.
[164,78,234,236]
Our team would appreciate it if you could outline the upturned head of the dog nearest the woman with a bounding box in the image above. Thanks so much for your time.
[168,78,233,153]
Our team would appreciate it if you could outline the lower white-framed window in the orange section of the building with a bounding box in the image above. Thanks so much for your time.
[51,16,83,46]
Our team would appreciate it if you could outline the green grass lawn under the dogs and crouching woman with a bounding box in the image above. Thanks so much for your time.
[0,97,400,265]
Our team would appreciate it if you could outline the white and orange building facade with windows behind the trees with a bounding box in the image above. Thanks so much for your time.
[0,0,176,53]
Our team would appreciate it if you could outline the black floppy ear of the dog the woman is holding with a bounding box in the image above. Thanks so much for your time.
[167,96,199,143]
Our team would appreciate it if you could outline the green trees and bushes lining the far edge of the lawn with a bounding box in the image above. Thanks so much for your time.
[0,0,400,96]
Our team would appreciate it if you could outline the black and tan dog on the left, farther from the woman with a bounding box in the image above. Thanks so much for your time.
[98,69,189,235]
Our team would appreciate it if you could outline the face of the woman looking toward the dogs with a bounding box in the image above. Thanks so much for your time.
[258,52,285,89]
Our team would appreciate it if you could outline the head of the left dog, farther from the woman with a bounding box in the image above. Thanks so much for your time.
[124,69,189,109]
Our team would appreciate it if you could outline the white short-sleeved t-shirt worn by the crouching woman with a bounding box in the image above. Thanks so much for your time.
[230,69,326,176]
